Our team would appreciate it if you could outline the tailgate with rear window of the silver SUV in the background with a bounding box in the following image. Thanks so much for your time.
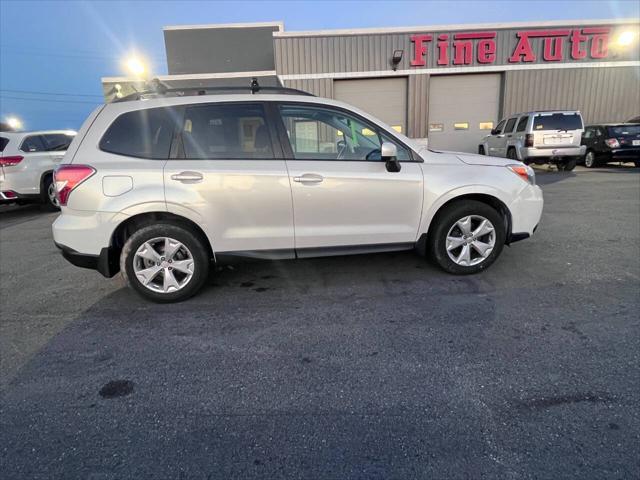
[532,112,584,149]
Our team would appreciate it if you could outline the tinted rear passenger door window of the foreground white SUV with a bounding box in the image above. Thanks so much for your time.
[182,104,274,159]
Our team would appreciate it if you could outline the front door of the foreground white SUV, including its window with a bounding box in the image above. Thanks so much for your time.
[278,104,423,249]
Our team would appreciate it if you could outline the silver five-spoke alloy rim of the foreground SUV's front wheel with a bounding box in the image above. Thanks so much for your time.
[446,215,496,267]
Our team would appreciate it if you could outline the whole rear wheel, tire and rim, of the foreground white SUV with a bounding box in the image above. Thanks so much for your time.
[120,224,209,303]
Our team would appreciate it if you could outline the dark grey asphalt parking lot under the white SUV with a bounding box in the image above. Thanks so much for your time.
[0,167,640,479]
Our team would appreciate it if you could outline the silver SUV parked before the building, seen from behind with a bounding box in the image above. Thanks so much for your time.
[478,110,585,171]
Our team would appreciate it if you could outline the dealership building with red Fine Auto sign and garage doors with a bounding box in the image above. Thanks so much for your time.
[102,19,640,151]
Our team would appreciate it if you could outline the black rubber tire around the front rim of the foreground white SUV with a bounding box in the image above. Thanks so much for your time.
[428,200,506,275]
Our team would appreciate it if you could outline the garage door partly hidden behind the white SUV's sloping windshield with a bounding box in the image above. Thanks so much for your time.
[333,78,407,134]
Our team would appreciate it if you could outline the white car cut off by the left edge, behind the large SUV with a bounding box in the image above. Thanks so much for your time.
[0,130,76,209]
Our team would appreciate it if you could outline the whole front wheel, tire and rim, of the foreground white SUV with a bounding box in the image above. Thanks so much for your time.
[429,200,506,275]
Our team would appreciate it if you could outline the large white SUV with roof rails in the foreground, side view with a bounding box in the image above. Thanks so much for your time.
[53,89,543,302]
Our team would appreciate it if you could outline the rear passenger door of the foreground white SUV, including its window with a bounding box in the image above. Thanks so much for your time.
[164,102,294,258]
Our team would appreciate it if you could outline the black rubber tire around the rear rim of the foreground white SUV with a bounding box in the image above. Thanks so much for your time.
[120,223,210,303]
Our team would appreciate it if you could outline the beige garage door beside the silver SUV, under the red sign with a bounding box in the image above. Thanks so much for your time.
[428,73,500,152]
